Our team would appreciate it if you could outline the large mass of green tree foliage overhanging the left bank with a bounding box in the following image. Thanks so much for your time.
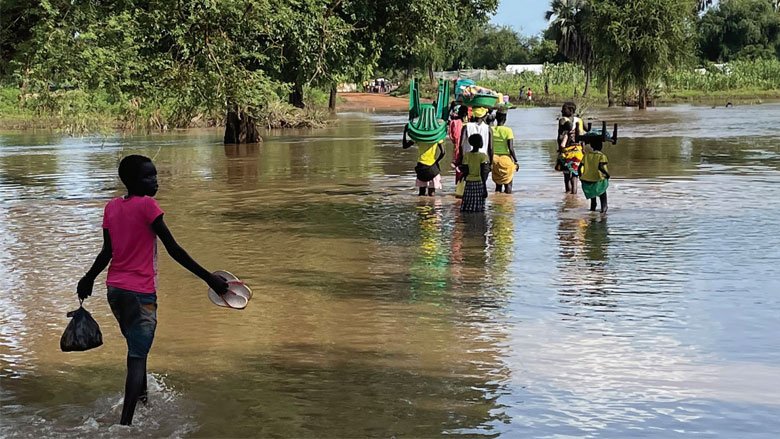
[0,0,498,127]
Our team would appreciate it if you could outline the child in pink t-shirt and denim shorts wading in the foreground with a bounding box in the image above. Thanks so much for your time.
[77,155,228,425]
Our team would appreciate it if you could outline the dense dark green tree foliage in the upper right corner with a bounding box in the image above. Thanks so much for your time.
[697,0,780,62]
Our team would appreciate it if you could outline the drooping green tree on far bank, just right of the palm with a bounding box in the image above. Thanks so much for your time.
[586,0,696,109]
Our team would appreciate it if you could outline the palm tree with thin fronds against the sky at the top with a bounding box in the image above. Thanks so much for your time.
[544,0,593,96]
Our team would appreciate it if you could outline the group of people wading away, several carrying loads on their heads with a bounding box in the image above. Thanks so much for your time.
[402,102,610,213]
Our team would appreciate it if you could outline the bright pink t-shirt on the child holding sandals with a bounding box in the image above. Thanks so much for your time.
[103,196,163,293]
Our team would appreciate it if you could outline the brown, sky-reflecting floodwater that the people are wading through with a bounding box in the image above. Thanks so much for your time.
[0,105,780,438]
